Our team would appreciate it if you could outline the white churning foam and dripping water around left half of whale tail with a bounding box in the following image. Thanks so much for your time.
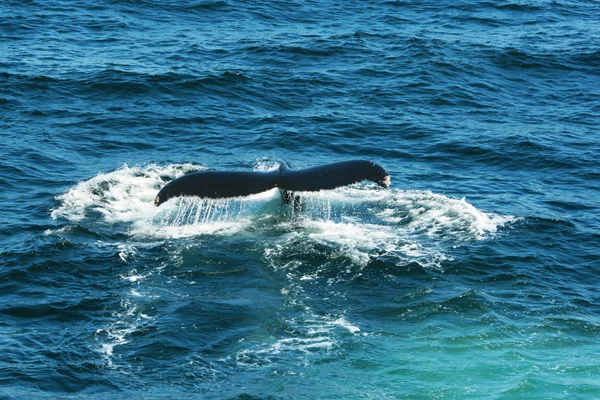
[48,164,279,239]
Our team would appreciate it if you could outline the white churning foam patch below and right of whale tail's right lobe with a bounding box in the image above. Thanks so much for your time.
[265,186,516,268]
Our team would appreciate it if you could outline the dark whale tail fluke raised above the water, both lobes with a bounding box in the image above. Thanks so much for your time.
[154,160,390,207]
